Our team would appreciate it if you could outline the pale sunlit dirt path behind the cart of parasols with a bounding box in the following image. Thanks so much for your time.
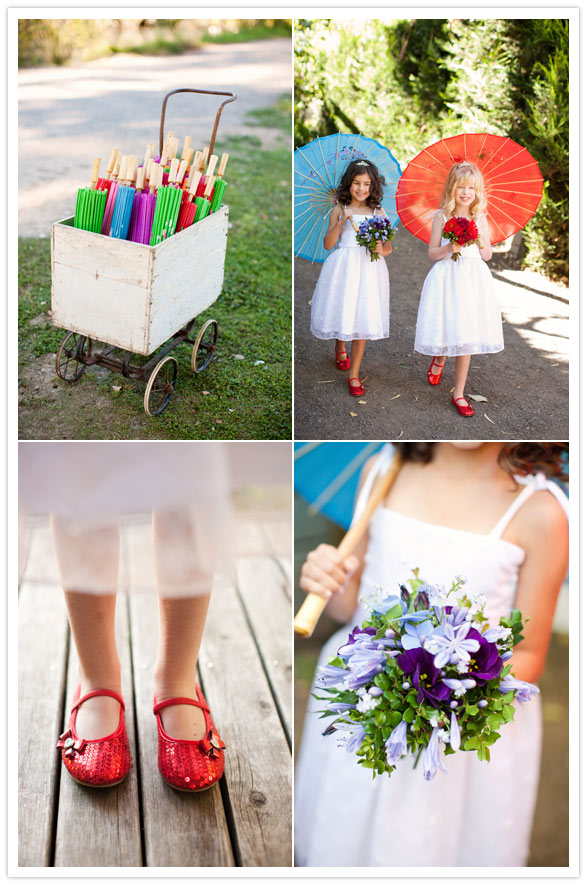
[18,38,291,237]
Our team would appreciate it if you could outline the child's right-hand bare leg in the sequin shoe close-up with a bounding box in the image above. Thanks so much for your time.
[153,509,212,740]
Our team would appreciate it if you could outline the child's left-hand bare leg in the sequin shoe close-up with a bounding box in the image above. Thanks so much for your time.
[51,517,121,739]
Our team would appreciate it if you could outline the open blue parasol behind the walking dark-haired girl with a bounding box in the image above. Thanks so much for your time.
[294,132,401,262]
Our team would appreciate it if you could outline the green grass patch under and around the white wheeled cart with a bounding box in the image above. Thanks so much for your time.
[19,102,291,440]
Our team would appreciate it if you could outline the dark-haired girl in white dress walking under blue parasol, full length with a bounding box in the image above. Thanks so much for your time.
[310,159,391,397]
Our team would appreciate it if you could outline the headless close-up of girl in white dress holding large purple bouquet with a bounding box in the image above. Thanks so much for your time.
[295,442,568,867]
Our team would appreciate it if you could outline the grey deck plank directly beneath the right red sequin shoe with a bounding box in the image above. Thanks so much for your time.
[128,526,234,867]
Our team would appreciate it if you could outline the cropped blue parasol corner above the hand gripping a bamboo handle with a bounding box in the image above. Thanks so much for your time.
[294,442,385,529]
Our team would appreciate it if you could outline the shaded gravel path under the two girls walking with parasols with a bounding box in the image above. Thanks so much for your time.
[294,227,569,440]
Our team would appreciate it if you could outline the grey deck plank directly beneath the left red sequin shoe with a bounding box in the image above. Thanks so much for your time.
[55,593,143,867]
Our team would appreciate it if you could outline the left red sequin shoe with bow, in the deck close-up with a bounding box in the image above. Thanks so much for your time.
[57,686,131,788]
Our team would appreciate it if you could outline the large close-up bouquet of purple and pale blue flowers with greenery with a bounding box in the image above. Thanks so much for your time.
[314,570,539,780]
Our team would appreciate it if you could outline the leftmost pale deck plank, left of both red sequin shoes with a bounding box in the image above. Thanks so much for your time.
[18,582,68,867]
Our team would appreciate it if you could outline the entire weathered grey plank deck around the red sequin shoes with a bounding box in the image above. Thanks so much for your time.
[19,523,291,867]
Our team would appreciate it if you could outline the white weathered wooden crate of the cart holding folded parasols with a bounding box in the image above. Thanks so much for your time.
[51,206,228,355]
